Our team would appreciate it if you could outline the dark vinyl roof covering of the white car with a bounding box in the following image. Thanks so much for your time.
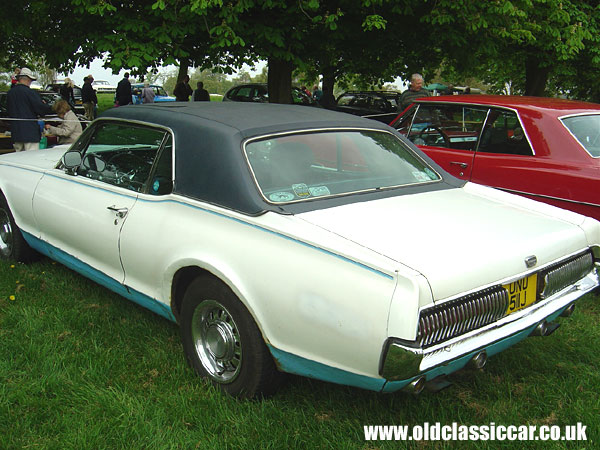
[101,102,460,215]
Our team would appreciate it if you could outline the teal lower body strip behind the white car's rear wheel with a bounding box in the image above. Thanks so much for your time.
[267,344,385,391]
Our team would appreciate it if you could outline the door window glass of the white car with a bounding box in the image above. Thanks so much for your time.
[77,122,167,192]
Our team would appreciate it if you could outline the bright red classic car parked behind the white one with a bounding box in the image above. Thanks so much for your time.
[391,95,600,220]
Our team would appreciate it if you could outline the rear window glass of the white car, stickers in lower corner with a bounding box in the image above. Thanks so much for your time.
[245,130,441,203]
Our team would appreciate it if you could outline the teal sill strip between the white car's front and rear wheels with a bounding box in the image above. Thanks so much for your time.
[21,230,176,322]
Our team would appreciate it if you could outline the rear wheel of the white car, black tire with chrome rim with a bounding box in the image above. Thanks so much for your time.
[180,276,282,398]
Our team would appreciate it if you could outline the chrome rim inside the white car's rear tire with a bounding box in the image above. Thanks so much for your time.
[191,300,242,384]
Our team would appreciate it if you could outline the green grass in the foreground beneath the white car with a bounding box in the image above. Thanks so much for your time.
[0,259,600,450]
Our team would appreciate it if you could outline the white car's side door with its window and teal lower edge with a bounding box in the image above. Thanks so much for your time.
[33,121,166,283]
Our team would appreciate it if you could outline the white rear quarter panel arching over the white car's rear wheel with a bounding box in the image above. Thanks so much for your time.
[121,196,406,377]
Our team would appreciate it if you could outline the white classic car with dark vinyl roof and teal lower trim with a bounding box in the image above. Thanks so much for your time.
[0,102,600,397]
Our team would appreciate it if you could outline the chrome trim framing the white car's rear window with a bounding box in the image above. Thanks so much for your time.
[242,127,444,206]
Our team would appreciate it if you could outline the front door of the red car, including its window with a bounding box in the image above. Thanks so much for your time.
[394,102,487,180]
